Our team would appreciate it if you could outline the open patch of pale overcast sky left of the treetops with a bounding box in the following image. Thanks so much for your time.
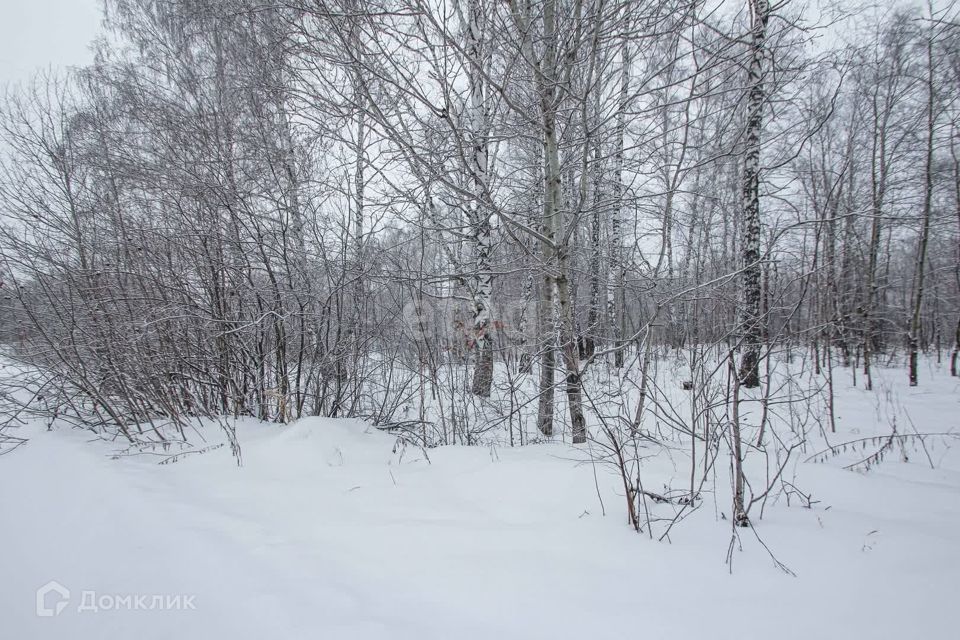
[0,0,100,85]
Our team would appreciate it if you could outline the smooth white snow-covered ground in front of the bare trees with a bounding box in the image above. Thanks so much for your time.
[0,360,960,640]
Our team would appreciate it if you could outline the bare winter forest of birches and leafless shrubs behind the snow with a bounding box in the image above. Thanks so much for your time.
[0,0,960,572]
